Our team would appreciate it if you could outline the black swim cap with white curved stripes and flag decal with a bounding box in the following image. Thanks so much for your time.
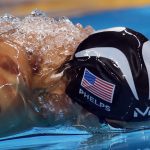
[66,27,150,122]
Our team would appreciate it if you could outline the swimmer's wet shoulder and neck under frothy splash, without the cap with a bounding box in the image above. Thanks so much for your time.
[0,10,94,136]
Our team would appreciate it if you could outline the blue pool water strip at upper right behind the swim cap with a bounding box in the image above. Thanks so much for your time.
[72,6,150,38]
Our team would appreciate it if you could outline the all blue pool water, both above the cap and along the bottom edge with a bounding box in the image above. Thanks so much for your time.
[0,6,150,150]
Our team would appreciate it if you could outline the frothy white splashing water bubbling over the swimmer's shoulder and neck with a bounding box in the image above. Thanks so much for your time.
[1,10,94,90]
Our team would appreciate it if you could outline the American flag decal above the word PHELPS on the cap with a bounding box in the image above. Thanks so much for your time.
[81,68,115,103]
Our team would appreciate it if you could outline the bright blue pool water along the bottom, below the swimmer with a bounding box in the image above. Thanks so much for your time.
[0,128,150,150]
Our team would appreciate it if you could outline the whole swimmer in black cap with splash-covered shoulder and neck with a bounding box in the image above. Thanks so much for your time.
[0,12,150,136]
